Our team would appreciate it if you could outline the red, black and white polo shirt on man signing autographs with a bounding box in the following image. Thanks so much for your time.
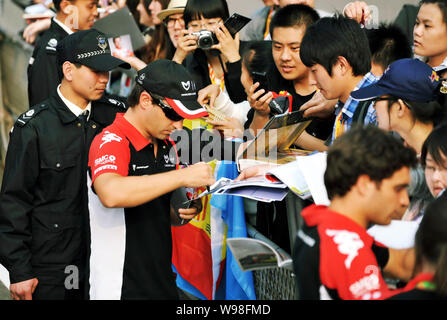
[89,114,178,299]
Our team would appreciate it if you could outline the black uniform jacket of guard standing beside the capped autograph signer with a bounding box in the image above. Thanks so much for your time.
[0,92,124,285]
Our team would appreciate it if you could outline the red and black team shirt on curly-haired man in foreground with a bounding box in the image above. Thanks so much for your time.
[293,205,408,300]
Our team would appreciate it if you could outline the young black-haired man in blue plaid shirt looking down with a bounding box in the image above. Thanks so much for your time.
[300,16,378,143]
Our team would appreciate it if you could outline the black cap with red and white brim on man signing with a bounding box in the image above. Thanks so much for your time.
[135,59,208,119]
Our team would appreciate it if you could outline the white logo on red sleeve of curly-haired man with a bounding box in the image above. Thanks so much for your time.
[326,229,365,269]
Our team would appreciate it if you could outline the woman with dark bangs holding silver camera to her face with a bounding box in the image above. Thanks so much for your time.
[173,0,250,103]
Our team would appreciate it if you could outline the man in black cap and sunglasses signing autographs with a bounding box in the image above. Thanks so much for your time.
[89,60,214,300]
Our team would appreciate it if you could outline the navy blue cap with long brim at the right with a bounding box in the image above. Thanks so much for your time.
[351,59,441,102]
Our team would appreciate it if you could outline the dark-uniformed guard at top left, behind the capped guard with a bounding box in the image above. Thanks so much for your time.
[28,0,98,108]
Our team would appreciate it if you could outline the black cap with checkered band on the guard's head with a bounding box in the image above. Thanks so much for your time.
[56,29,130,71]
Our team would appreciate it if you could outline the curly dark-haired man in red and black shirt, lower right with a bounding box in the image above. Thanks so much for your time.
[293,125,417,300]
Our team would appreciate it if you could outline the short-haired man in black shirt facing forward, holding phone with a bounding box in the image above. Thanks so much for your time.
[248,4,332,144]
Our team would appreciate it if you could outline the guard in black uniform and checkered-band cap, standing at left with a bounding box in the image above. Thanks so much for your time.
[0,29,130,300]
